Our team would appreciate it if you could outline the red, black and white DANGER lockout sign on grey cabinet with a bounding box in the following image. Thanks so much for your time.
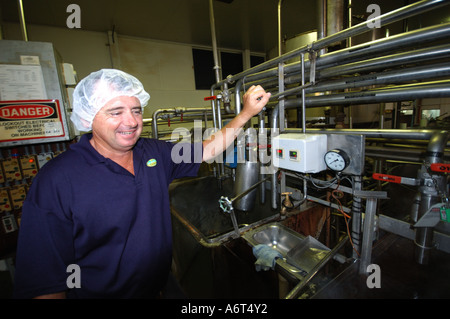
[0,100,65,142]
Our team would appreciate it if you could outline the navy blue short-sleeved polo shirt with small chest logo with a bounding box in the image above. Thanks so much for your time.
[14,134,202,298]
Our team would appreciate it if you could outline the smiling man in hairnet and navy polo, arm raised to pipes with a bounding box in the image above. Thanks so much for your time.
[14,69,270,298]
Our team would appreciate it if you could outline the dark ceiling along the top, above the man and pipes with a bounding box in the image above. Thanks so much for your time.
[0,0,444,52]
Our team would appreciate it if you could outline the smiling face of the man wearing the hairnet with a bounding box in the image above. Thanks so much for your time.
[92,96,143,152]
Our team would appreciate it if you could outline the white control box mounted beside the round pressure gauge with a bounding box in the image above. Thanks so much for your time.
[272,133,327,173]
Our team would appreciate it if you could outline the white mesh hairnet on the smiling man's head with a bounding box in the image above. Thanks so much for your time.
[70,69,150,132]
